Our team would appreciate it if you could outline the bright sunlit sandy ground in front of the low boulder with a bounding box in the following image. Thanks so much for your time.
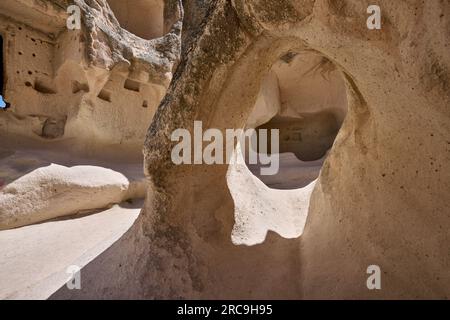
[0,201,142,299]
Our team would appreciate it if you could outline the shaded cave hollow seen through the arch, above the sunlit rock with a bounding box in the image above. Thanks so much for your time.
[245,51,347,189]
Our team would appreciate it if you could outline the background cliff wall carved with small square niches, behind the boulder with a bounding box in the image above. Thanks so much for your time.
[0,0,181,154]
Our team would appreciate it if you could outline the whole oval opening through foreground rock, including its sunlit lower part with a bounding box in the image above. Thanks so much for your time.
[227,50,348,245]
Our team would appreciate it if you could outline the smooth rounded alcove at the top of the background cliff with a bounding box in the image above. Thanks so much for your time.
[108,0,164,40]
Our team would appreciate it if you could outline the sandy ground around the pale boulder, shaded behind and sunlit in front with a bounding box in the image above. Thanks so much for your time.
[0,138,145,299]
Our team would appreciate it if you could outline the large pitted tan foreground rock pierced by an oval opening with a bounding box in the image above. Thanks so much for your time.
[0,0,450,299]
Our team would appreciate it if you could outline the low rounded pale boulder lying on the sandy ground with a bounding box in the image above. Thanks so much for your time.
[0,164,145,229]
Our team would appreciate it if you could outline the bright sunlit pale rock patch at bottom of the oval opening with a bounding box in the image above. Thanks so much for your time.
[227,145,314,245]
